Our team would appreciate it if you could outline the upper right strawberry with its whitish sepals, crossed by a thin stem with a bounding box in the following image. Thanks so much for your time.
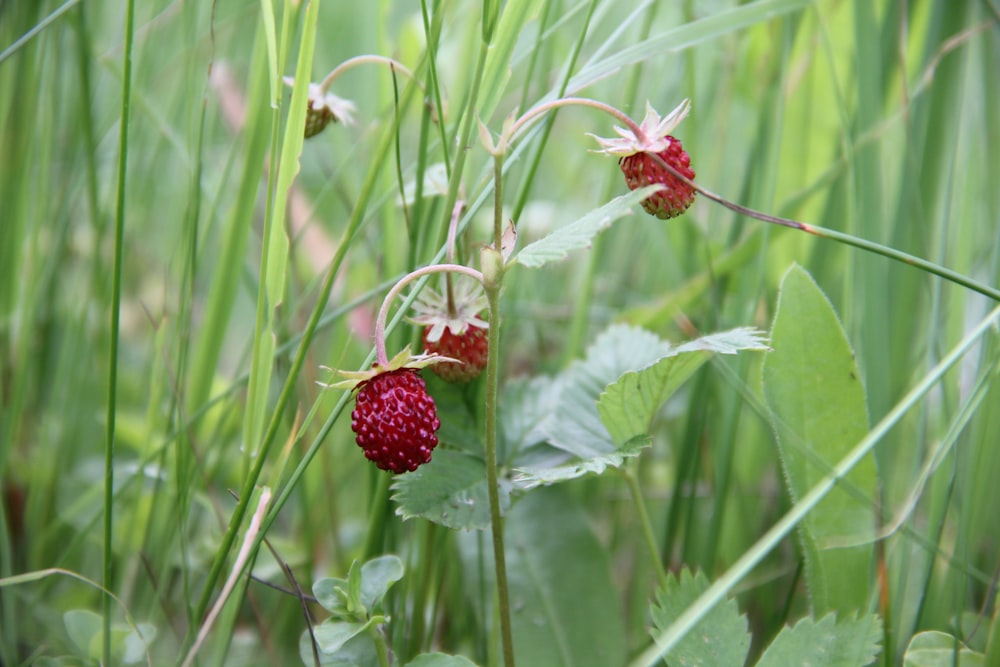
[591,100,695,220]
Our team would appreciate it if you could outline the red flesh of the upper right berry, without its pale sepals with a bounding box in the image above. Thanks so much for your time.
[618,136,695,220]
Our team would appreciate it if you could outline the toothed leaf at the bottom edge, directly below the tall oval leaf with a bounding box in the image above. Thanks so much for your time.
[757,614,882,667]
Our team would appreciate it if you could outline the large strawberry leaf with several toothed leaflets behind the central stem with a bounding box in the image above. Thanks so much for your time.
[392,325,766,529]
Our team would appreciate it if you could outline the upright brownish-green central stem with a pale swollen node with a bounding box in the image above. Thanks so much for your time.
[482,153,514,667]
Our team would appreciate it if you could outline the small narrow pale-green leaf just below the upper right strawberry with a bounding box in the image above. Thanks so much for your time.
[514,185,660,268]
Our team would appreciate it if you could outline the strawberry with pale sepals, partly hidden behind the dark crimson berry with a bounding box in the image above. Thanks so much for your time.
[410,282,490,382]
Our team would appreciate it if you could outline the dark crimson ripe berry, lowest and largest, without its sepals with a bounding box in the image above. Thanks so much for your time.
[351,368,441,473]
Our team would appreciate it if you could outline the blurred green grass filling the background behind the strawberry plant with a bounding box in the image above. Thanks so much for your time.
[0,0,1000,665]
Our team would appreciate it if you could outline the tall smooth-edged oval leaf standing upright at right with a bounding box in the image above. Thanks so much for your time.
[763,266,878,614]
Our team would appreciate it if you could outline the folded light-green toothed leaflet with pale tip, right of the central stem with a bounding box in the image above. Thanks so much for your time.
[597,328,769,445]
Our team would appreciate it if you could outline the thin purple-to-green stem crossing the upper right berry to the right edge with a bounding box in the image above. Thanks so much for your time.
[646,153,1000,301]
